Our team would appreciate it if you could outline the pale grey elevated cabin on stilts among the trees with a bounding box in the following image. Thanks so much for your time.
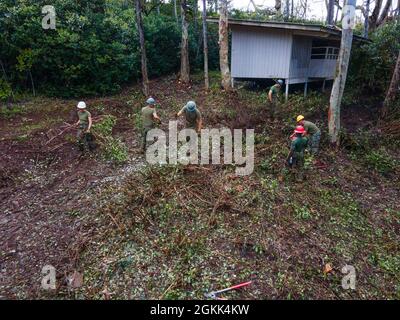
[207,18,368,99]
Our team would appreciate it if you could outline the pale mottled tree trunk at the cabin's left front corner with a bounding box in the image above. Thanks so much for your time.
[219,0,232,90]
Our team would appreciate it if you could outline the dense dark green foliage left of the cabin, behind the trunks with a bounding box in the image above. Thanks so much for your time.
[0,0,217,100]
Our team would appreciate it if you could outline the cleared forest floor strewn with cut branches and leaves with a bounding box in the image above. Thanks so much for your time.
[0,76,400,299]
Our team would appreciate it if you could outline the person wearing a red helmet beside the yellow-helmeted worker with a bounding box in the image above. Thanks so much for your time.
[287,126,308,182]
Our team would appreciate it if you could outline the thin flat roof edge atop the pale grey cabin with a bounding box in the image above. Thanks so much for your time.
[207,18,370,41]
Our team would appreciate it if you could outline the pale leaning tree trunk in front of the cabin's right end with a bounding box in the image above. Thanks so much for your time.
[328,0,356,146]
